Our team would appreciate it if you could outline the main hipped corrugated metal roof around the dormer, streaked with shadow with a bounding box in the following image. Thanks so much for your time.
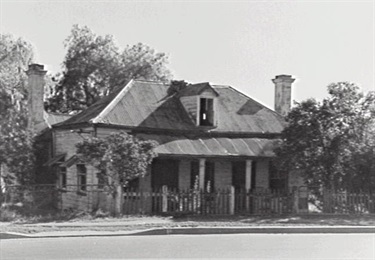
[56,80,285,133]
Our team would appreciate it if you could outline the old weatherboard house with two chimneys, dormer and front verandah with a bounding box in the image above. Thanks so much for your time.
[28,64,304,213]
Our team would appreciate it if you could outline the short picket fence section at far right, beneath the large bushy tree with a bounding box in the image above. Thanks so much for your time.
[323,190,375,214]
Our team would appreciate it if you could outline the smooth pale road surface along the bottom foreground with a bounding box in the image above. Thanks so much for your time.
[0,234,375,260]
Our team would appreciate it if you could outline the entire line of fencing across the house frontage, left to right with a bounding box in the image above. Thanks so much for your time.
[4,185,375,215]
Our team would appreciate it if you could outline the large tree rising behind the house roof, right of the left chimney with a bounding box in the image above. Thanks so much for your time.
[47,25,171,112]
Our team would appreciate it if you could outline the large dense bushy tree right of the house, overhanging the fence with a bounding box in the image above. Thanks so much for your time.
[276,82,375,196]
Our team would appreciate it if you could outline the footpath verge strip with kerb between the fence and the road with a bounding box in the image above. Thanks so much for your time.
[0,215,375,239]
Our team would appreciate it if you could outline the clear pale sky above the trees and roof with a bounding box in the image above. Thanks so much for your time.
[0,0,375,108]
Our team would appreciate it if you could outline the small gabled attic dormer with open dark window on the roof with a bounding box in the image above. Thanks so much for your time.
[178,82,219,127]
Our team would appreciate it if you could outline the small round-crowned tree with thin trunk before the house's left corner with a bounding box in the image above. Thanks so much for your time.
[76,132,157,214]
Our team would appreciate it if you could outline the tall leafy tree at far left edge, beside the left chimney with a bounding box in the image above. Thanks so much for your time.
[0,34,35,184]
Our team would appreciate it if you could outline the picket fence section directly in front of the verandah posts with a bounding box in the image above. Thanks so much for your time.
[123,187,294,215]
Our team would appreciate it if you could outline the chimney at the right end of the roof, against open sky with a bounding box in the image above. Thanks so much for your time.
[272,75,295,116]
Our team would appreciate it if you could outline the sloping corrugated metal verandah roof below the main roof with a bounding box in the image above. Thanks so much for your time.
[137,134,277,157]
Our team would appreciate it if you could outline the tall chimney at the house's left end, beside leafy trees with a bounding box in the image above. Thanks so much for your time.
[26,64,47,133]
